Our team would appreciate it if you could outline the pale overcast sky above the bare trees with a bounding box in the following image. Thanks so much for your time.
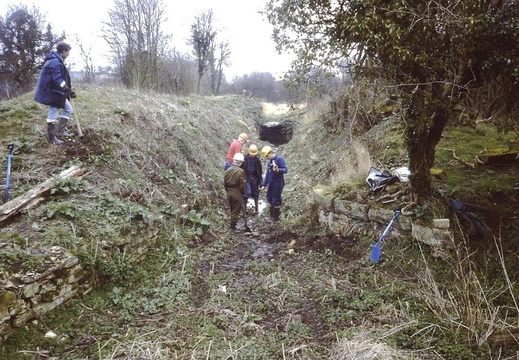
[0,0,292,80]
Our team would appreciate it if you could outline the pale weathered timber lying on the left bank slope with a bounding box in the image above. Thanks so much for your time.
[0,164,85,225]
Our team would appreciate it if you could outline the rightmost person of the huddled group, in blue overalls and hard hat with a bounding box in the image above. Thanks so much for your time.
[261,146,288,222]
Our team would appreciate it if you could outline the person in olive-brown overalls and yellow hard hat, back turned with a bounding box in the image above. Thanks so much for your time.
[223,152,247,230]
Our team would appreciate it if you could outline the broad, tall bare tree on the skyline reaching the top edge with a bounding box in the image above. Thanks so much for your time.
[103,0,169,90]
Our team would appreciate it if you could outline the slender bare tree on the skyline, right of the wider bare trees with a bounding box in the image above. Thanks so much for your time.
[188,10,217,94]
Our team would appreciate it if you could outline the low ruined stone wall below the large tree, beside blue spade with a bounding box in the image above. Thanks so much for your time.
[313,186,452,256]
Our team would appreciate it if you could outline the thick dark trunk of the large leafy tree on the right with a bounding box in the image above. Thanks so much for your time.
[405,91,449,199]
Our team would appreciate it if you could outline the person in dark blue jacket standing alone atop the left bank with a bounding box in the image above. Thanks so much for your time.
[34,42,76,145]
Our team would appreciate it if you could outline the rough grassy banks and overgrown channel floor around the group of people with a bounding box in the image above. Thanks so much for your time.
[0,87,518,359]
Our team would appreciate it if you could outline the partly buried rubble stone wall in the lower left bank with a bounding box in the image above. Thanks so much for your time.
[0,229,158,345]
